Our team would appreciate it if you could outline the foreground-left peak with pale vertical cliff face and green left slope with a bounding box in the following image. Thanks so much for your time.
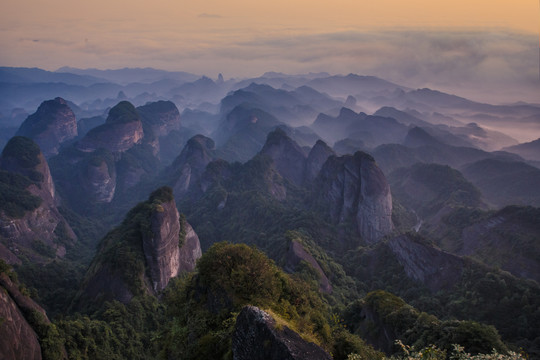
[75,187,201,309]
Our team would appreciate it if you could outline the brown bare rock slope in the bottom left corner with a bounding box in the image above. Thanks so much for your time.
[0,273,48,360]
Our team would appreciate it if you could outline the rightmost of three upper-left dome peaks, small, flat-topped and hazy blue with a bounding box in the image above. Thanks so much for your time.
[137,101,181,137]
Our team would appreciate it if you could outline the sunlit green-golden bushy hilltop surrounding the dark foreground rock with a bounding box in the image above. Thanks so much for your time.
[161,242,377,359]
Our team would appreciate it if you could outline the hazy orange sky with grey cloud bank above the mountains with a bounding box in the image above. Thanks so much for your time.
[0,0,540,99]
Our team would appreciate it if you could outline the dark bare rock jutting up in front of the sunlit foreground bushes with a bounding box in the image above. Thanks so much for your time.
[232,306,331,360]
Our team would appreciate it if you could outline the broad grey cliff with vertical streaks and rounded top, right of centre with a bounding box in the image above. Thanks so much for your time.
[315,151,393,244]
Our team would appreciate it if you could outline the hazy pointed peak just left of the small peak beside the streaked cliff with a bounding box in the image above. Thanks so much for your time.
[260,128,306,185]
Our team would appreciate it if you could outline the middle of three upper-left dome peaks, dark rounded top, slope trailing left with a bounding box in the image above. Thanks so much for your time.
[77,101,144,153]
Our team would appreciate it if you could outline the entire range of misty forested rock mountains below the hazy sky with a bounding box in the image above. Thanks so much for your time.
[0,67,540,359]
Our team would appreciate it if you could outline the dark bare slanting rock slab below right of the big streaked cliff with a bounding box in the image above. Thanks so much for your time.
[388,235,464,292]
